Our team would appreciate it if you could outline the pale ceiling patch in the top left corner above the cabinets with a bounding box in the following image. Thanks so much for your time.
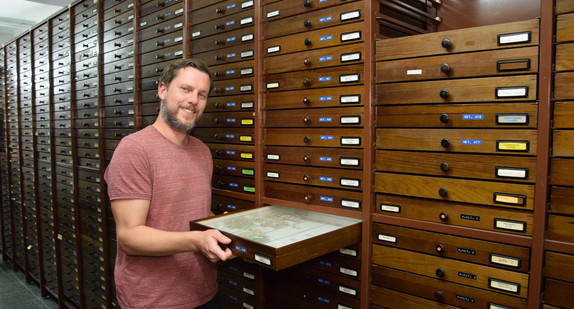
[0,0,73,46]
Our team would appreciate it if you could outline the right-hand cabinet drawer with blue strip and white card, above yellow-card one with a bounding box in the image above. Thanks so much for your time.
[376,103,540,128]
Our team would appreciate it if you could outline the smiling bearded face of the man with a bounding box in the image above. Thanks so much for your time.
[158,67,210,132]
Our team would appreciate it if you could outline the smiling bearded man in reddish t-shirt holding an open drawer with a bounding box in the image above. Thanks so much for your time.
[105,59,232,309]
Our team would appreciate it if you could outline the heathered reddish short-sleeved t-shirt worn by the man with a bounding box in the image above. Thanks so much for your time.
[105,126,217,309]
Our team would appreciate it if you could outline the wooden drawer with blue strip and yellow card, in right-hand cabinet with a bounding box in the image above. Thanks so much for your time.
[376,128,537,155]
